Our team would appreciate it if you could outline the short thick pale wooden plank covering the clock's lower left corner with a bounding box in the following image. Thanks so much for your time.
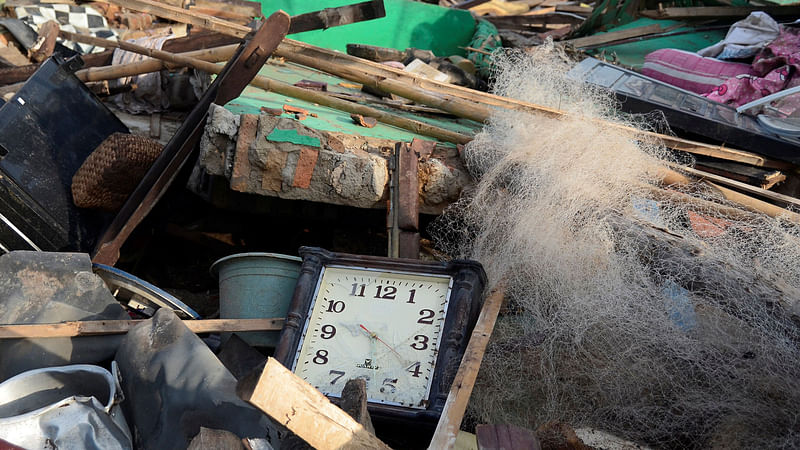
[242,358,389,450]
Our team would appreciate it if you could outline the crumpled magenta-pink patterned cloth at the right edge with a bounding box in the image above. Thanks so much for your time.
[707,28,800,114]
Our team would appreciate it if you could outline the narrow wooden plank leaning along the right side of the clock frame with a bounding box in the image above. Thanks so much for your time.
[428,284,505,450]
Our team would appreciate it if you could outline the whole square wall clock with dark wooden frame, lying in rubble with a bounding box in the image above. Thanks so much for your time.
[274,247,486,421]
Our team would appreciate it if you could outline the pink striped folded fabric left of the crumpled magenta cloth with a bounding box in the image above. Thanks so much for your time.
[641,48,755,94]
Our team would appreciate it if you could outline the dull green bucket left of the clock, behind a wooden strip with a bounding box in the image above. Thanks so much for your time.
[211,253,302,347]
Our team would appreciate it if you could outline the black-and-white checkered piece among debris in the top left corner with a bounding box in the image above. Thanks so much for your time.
[14,4,117,54]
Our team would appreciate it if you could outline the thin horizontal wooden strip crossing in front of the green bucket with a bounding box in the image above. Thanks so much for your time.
[0,318,284,339]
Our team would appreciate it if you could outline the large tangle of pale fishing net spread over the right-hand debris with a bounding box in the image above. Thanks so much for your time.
[431,46,800,448]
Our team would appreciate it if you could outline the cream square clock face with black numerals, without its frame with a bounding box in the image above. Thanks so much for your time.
[292,266,452,409]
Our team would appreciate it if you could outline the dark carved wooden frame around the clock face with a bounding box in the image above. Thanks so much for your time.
[273,247,486,423]
